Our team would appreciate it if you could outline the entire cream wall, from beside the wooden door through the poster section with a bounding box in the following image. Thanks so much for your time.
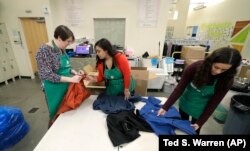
[0,0,169,77]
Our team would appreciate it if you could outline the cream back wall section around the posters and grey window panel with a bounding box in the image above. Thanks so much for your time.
[51,0,169,56]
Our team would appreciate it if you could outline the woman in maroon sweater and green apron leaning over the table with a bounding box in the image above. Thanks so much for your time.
[158,47,241,134]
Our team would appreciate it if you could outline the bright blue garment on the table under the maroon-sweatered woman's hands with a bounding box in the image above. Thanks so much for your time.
[140,96,196,135]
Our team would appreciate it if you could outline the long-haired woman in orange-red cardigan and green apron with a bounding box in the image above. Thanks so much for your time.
[86,38,135,99]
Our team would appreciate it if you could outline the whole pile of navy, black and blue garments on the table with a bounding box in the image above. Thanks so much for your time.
[93,93,196,146]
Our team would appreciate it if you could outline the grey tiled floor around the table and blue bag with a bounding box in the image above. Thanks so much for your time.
[0,79,223,151]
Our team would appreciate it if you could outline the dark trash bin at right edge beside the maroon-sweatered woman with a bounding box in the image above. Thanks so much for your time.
[223,95,250,135]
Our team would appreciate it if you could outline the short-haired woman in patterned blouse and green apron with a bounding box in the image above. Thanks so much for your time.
[36,25,83,120]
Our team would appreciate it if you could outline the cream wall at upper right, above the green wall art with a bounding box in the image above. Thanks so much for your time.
[187,0,250,59]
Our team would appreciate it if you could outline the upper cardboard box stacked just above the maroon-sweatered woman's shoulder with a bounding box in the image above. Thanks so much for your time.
[181,46,206,60]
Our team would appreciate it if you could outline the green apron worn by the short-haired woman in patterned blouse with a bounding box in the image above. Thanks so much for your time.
[43,41,71,119]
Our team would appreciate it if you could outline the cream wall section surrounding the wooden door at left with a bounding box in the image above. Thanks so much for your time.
[0,0,52,78]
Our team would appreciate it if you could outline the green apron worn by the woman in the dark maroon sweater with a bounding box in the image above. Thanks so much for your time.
[179,80,217,119]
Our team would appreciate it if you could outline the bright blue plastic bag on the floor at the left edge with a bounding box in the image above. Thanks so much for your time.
[0,106,29,150]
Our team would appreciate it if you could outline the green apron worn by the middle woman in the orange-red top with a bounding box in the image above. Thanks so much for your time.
[104,62,135,95]
